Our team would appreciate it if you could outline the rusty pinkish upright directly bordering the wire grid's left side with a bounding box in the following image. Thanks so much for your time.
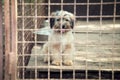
[11,0,17,80]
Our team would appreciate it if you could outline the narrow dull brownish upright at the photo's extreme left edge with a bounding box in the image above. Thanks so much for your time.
[0,0,3,80]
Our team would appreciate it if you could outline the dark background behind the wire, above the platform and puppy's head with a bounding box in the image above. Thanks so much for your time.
[47,0,120,19]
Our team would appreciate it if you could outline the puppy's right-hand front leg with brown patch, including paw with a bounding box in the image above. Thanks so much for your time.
[62,44,74,66]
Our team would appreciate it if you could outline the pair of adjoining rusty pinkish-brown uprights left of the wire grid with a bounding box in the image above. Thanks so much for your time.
[4,0,17,80]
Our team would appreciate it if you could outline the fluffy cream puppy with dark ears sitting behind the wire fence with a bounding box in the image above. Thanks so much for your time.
[42,11,75,66]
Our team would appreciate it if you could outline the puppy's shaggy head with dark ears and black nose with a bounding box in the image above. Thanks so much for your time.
[50,11,74,33]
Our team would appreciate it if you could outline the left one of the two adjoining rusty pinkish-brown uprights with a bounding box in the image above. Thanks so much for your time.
[4,0,10,80]
